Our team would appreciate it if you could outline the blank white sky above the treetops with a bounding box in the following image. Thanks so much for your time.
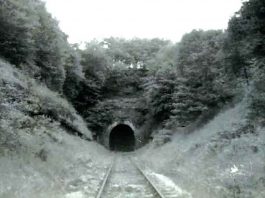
[43,0,242,43]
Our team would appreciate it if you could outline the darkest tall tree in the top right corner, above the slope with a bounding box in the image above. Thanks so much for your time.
[224,0,265,81]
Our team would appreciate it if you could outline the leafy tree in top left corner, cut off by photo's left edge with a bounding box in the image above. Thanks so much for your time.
[0,0,35,66]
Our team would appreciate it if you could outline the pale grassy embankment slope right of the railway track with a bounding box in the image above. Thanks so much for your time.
[140,97,265,198]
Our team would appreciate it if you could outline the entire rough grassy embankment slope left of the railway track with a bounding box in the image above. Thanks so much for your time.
[0,60,111,198]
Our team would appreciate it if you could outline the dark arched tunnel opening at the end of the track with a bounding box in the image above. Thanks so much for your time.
[109,124,135,152]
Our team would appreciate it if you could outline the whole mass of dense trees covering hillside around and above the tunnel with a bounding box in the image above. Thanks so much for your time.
[0,0,265,138]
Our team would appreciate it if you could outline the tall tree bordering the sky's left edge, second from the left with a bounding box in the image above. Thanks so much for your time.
[34,1,69,92]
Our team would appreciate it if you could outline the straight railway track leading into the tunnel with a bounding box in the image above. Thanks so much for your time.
[96,155,178,198]
